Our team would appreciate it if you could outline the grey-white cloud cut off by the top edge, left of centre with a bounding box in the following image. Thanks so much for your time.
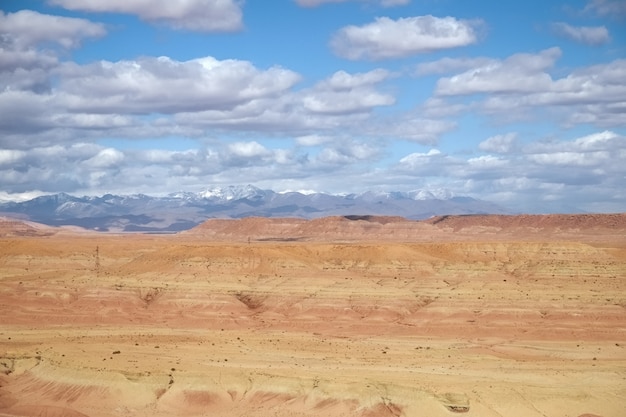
[48,0,243,32]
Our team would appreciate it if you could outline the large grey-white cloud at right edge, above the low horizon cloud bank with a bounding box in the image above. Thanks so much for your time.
[435,48,626,128]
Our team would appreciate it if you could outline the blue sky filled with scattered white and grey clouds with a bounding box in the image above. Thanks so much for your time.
[0,0,626,213]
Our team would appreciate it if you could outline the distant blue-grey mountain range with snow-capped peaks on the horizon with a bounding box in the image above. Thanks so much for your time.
[0,185,511,232]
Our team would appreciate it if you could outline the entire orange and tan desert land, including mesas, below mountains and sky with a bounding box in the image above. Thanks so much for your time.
[0,214,626,417]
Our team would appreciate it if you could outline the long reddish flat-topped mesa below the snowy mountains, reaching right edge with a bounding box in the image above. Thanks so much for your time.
[184,213,626,242]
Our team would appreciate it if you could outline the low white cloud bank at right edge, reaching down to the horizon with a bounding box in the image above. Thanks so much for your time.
[392,131,626,212]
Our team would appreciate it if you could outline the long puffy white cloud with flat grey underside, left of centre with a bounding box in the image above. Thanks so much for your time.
[53,57,300,114]
